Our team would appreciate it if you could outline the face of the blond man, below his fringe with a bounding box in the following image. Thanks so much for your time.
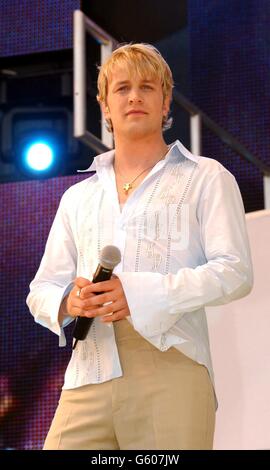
[102,66,170,139]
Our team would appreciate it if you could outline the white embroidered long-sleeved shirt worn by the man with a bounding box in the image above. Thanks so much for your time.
[27,141,253,396]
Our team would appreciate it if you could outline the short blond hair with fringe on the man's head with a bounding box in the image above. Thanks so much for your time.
[97,43,173,130]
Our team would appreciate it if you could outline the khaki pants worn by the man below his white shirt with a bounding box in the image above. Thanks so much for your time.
[44,320,215,450]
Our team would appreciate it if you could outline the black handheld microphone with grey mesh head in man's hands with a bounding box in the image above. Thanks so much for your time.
[72,245,121,349]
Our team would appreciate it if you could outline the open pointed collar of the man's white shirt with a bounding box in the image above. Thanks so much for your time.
[77,140,199,173]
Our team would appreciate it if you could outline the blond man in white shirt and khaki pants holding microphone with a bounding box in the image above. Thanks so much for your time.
[27,44,252,449]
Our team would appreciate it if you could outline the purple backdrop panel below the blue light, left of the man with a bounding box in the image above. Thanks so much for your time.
[0,174,86,449]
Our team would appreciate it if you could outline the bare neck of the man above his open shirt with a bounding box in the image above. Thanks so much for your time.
[112,135,168,174]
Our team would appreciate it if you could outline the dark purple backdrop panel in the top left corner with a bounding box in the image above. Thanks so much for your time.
[0,0,80,57]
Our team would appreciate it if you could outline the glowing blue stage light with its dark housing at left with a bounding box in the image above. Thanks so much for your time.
[0,106,77,180]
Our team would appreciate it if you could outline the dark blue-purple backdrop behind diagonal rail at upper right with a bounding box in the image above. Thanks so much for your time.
[188,0,270,212]
